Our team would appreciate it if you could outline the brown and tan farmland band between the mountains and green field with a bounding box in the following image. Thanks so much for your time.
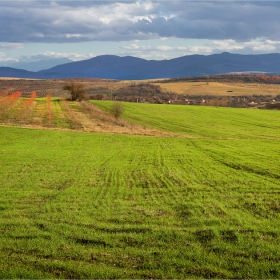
[0,75,280,109]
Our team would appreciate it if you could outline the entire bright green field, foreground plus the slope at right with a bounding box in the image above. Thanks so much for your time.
[0,102,280,279]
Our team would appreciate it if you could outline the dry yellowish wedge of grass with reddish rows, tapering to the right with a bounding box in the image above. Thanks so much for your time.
[0,97,178,136]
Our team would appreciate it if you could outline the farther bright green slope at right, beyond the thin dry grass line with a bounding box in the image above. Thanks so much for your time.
[94,101,280,139]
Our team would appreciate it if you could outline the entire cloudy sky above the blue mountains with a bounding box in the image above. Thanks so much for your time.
[0,0,280,66]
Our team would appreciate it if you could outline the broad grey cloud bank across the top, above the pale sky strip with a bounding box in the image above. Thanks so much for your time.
[0,0,280,43]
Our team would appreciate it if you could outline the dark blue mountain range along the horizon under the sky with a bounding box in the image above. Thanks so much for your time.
[0,53,280,80]
